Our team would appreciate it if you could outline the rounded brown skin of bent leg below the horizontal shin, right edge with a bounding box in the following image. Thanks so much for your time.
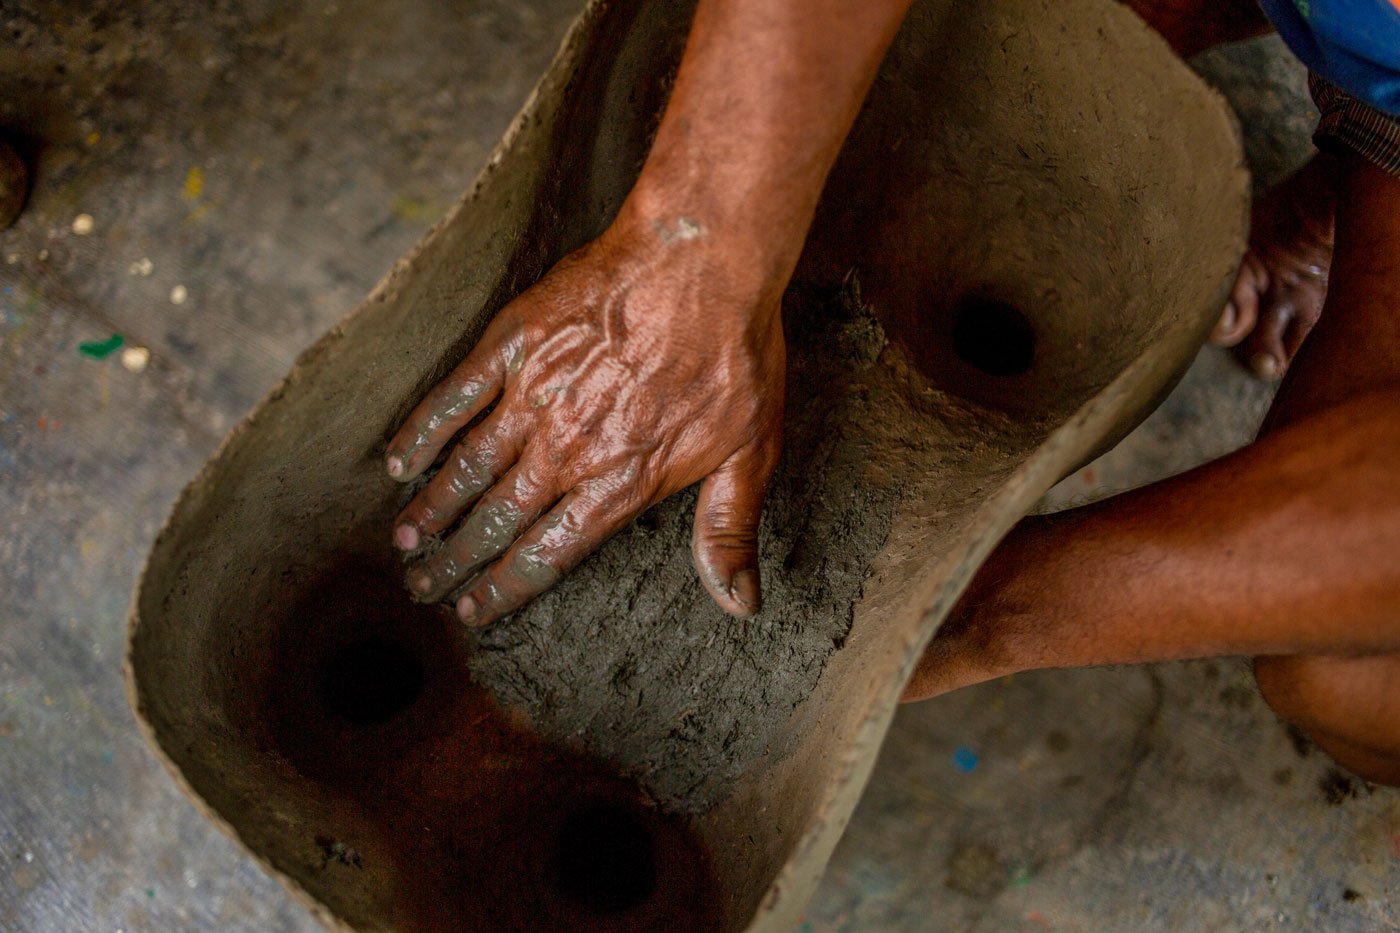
[1254,654,1400,785]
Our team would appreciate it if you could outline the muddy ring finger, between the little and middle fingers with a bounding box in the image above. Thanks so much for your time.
[393,408,524,551]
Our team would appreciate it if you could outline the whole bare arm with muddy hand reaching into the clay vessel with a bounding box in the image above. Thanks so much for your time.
[386,0,910,625]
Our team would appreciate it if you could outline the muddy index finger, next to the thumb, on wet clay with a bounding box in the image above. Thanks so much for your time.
[456,493,634,626]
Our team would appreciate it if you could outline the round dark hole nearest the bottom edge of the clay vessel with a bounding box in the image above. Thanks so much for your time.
[557,804,657,913]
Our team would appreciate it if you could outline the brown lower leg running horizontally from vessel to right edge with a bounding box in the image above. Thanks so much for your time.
[941,389,1400,671]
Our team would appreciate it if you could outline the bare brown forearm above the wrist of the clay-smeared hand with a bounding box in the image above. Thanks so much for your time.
[624,0,910,291]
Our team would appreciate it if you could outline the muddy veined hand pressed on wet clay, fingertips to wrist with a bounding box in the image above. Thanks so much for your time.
[386,207,784,625]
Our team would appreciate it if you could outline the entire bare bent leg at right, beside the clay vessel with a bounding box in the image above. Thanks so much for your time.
[906,158,1400,780]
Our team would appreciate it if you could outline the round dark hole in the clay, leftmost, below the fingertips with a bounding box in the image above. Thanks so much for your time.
[322,639,426,726]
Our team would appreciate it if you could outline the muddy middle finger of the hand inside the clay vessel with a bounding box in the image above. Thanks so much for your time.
[409,455,559,601]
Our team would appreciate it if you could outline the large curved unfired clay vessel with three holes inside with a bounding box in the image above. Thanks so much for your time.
[129,0,1246,930]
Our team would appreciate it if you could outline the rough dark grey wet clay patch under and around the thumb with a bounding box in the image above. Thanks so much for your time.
[469,275,1019,813]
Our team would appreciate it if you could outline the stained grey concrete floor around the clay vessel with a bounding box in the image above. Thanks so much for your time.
[0,0,1400,932]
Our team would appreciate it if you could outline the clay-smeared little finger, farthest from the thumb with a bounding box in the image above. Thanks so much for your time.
[384,329,521,482]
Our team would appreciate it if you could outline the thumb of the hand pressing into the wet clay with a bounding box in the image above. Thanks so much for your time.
[690,445,777,615]
